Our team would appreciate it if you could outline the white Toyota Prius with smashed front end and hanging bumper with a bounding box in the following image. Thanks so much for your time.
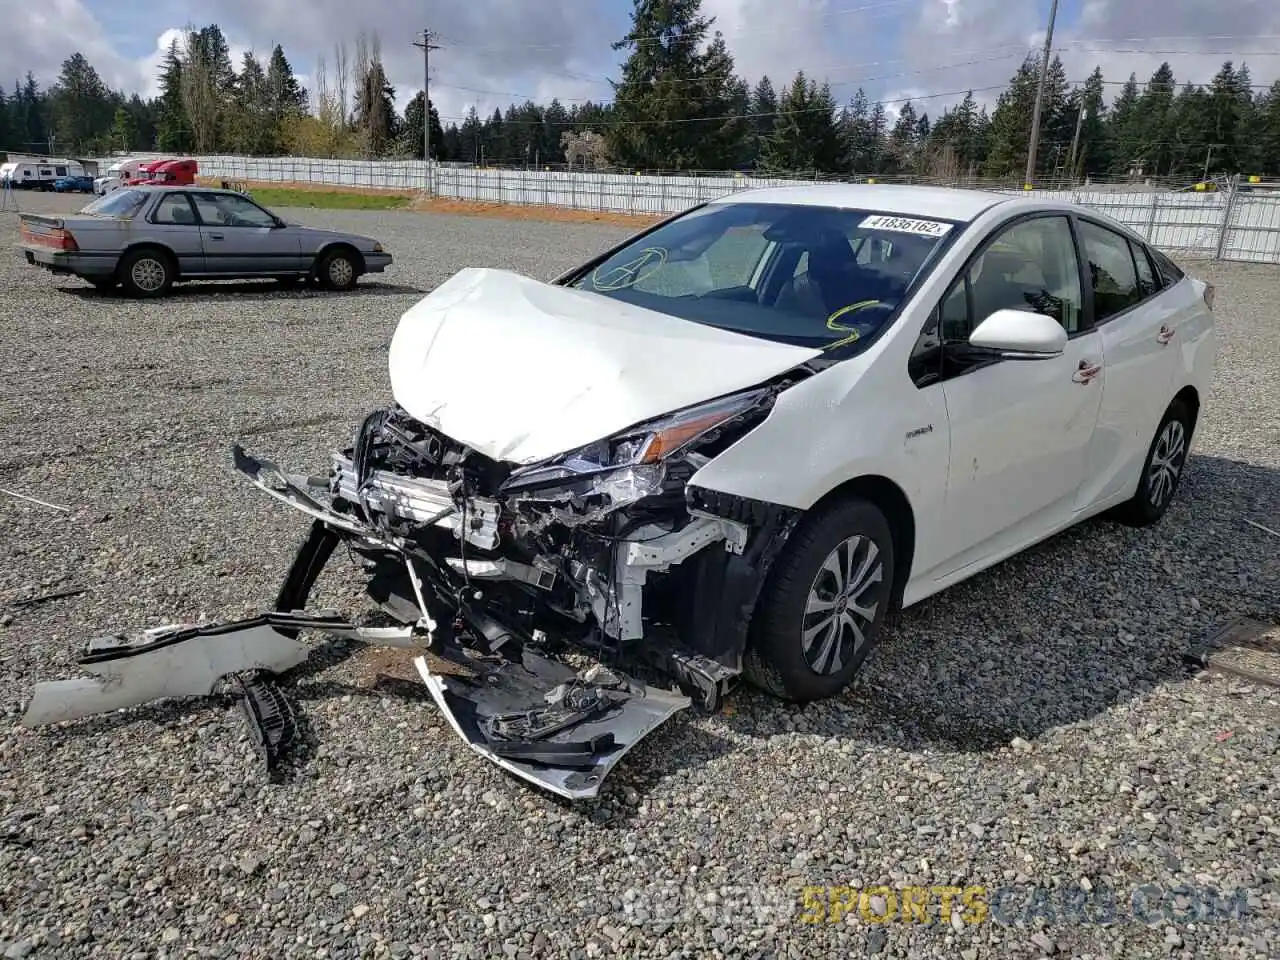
[27,184,1215,797]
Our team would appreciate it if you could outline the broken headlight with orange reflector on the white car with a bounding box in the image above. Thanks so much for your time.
[502,389,768,508]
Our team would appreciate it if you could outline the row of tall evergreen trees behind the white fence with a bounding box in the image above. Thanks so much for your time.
[0,0,1280,179]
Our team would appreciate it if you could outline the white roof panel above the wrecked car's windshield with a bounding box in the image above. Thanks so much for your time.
[712,183,1010,223]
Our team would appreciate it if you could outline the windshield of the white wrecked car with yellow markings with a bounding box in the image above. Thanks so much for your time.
[571,202,956,348]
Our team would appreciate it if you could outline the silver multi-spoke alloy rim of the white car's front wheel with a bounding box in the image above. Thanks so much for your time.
[801,534,884,676]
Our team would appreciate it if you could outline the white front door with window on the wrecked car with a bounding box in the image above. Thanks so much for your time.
[937,215,1103,577]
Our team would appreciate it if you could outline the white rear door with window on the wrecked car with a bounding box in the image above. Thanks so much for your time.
[1078,216,1187,509]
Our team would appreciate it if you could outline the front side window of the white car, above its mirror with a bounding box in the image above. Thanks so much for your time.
[909,215,1083,388]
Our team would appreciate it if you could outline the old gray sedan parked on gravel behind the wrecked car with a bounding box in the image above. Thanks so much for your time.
[20,186,392,297]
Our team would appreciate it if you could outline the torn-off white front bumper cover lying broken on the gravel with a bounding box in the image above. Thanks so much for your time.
[23,447,691,800]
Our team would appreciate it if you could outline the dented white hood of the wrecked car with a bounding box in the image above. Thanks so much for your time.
[388,268,820,463]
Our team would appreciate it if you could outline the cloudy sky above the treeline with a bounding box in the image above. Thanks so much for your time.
[0,0,1280,123]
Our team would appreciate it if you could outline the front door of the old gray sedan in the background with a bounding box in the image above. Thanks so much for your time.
[191,191,303,276]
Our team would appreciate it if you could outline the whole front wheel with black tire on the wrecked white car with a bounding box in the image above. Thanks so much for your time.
[744,499,895,703]
